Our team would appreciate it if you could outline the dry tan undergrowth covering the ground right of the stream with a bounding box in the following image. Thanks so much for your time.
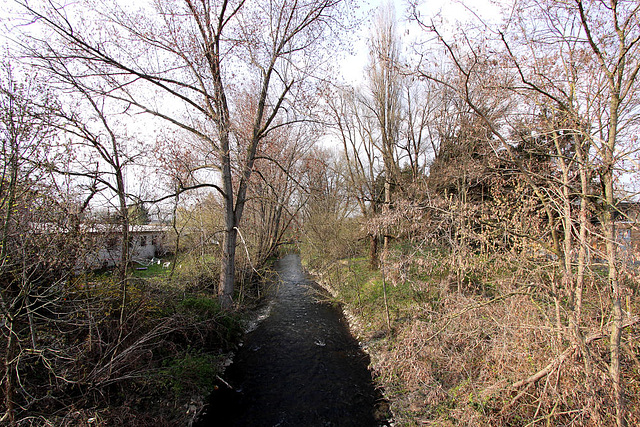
[307,248,640,426]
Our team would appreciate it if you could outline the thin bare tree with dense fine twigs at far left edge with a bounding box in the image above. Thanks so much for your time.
[0,63,77,425]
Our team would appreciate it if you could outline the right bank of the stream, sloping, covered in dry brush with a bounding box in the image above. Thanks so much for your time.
[308,258,624,426]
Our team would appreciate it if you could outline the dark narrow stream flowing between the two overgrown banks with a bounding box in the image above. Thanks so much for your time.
[197,255,388,427]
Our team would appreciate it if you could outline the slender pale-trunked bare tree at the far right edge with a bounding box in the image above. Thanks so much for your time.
[565,0,640,427]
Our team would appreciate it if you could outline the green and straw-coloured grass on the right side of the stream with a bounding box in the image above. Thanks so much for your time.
[304,248,624,425]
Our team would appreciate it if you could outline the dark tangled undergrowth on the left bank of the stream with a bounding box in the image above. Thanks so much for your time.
[6,261,252,427]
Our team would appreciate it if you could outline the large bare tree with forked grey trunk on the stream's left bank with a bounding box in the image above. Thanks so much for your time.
[19,0,348,308]
